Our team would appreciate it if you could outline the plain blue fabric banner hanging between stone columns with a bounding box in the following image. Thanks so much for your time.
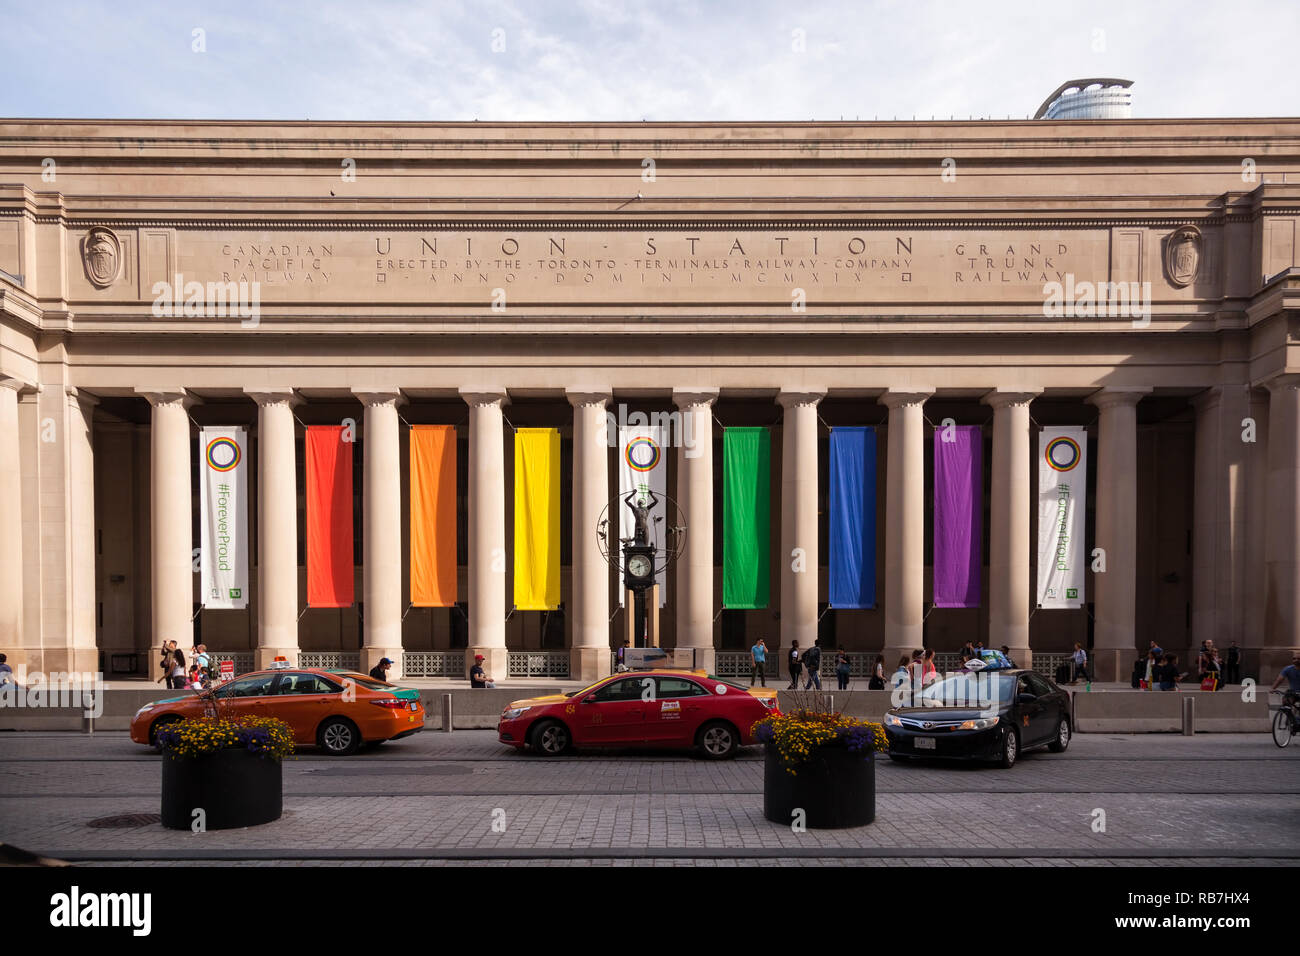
[827,428,876,607]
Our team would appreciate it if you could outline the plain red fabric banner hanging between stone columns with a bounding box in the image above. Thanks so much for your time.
[306,425,354,607]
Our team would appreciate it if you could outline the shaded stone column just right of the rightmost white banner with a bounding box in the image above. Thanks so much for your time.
[1084,388,1151,680]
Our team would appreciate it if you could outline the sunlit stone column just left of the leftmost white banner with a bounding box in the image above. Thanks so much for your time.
[138,389,194,650]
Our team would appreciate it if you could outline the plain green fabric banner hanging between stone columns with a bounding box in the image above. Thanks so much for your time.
[723,428,772,609]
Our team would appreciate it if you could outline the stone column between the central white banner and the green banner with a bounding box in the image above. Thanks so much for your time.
[670,389,718,671]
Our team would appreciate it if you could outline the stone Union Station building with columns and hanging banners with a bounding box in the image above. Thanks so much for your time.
[0,120,1300,680]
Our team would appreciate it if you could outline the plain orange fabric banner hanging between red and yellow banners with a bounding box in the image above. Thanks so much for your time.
[411,425,456,607]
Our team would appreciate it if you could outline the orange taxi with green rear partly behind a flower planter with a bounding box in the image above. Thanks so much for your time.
[131,667,424,756]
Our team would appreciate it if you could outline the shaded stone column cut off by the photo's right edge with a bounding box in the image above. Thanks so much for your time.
[1260,375,1300,684]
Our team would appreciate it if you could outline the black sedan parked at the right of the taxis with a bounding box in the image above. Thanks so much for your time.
[884,670,1073,767]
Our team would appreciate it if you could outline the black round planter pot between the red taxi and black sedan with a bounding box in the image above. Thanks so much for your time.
[763,745,876,830]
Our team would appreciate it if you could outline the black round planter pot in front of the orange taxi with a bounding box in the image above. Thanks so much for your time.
[163,748,285,830]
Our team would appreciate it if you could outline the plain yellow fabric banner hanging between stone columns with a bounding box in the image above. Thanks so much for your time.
[515,428,560,611]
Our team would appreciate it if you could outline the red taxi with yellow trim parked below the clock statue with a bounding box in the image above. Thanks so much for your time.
[497,670,776,760]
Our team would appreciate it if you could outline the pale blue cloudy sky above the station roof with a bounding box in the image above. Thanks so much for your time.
[0,0,1300,121]
